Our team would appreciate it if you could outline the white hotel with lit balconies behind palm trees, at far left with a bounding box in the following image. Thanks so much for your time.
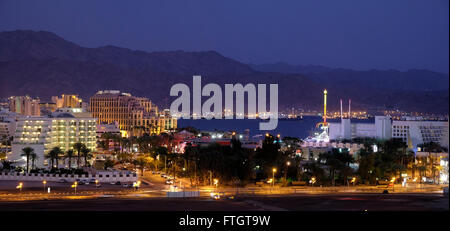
[8,108,97,168]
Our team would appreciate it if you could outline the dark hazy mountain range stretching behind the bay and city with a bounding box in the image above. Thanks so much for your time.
[0,30,449,114]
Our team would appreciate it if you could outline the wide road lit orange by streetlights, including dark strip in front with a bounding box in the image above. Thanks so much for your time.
[0,173,449,211]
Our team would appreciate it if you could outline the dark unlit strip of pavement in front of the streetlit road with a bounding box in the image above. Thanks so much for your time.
[0,194,449,211]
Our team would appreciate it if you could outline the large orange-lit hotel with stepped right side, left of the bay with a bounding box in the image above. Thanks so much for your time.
[89,90,177,136]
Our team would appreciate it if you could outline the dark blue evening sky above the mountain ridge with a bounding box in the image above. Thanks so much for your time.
[0,0,449,73]
